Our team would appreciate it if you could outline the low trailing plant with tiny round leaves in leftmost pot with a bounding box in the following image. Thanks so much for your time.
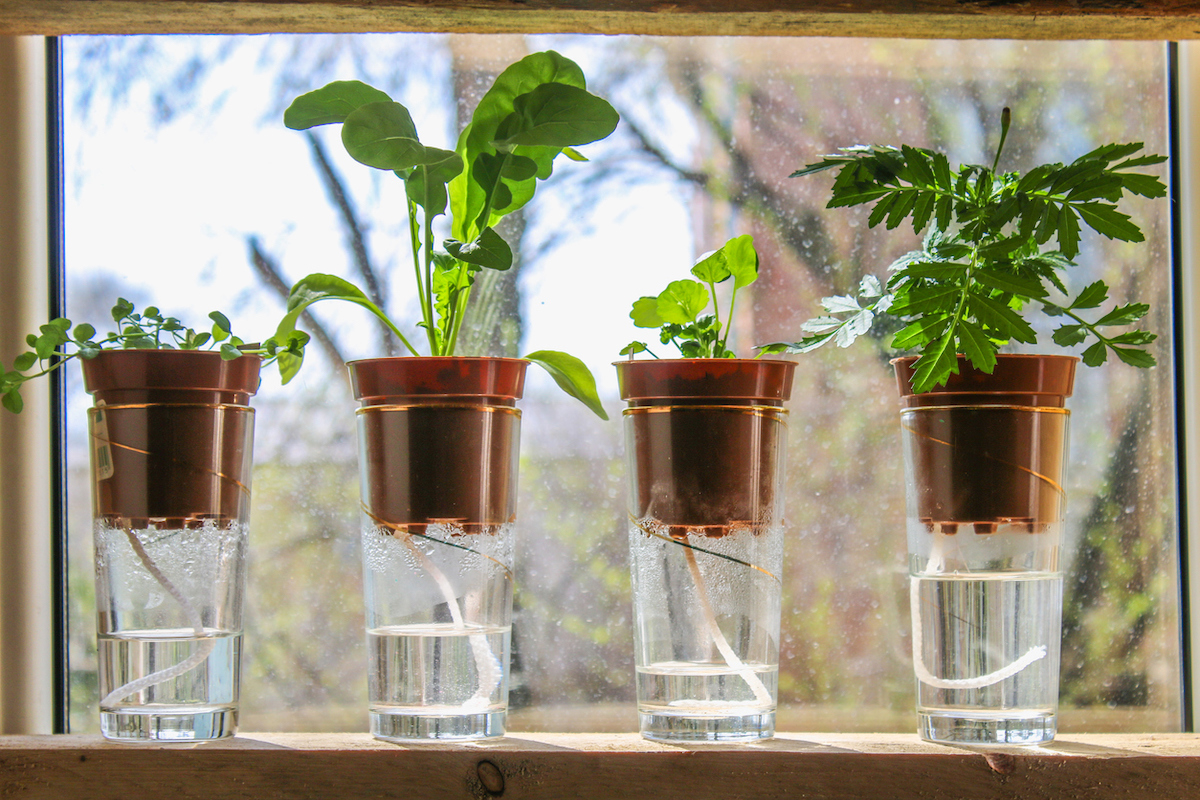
[0,297,308,414]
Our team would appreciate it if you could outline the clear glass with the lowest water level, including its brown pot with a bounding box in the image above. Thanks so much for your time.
[617,359,794,742]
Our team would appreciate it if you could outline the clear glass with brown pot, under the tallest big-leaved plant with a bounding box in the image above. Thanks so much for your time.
[350,357,526,741]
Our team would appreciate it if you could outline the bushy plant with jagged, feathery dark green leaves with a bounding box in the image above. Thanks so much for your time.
[764,108,1166,391]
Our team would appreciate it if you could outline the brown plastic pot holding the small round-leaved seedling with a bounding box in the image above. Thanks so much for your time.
[614,359,796,536]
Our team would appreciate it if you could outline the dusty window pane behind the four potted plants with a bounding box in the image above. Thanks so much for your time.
[64,35,1181,732]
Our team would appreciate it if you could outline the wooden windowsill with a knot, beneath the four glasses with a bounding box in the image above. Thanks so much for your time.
[0,733,1200,800]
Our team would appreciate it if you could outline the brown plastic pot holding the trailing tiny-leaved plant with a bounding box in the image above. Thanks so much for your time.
[80,350,262,528]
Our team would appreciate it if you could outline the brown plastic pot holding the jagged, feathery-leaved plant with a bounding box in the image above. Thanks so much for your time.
[892,354,1079,534]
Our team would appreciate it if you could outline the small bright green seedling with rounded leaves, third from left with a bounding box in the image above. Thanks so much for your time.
[620,234,758,359]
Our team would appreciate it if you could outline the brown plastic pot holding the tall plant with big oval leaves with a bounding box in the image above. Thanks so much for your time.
[347,356,528,533]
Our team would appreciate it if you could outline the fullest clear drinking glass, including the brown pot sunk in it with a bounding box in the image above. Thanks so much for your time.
[900,357,1073,744]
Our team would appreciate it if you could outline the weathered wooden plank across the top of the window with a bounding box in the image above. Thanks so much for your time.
[0,0,1200,40]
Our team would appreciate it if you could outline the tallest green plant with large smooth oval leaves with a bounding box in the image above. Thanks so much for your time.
[276,52,619,419]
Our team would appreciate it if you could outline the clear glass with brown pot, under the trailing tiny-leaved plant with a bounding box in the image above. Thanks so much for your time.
[84,351,258,741]
